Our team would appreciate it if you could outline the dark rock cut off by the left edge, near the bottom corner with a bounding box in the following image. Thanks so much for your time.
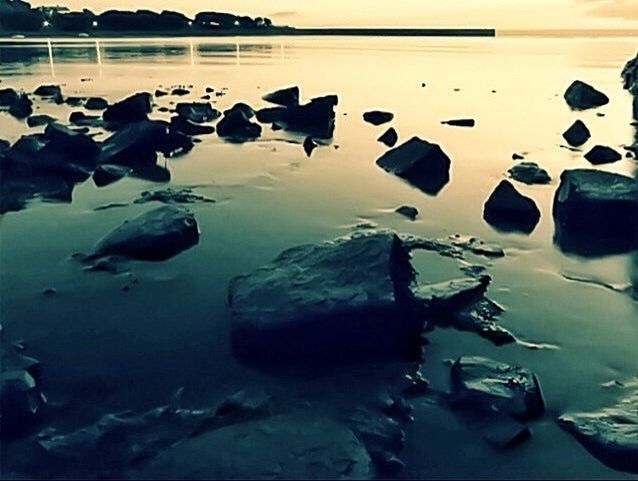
[0,342,47,441]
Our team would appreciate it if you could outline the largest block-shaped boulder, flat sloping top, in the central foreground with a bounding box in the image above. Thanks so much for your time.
[228,232,422,363]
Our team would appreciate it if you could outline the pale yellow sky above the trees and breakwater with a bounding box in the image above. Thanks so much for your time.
[31,0,638,29]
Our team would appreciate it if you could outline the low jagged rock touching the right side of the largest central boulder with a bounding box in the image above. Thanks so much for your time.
[414,275,516,346]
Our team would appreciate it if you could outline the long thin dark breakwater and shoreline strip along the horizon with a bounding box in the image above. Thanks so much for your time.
[0,27,496,44]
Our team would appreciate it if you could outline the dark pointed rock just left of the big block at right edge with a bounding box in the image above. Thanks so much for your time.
[483,180,541,233]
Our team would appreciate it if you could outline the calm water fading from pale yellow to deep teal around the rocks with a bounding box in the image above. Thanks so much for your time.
[0,37,638,478]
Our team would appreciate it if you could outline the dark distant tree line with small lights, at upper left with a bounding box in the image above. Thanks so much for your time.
[0,0,273,34]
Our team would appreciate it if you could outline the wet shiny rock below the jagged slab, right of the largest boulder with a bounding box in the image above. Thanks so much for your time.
[450,356,545,420]
